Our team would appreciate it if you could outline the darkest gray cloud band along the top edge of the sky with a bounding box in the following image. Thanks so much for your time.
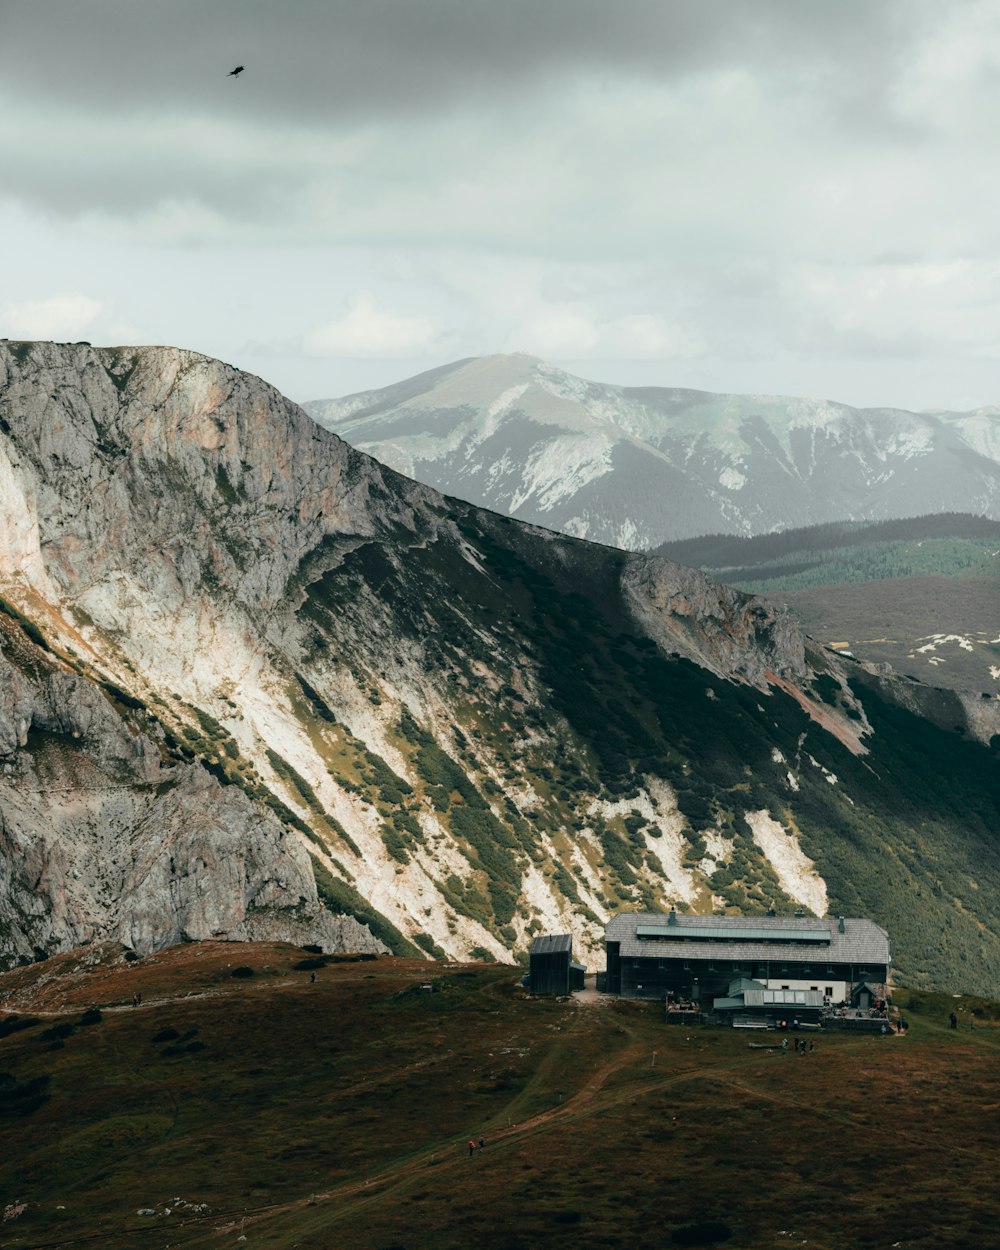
[0,0,921,126]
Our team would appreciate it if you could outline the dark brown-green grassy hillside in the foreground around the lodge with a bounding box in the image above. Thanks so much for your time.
[0,944,1000,1250]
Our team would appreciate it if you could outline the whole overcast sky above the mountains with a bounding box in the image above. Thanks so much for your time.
[0,0,1000,409]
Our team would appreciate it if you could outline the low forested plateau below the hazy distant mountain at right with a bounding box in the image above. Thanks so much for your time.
[656,513,1000,694]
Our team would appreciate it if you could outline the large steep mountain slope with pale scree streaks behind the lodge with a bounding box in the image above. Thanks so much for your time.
[0,344,1000,989]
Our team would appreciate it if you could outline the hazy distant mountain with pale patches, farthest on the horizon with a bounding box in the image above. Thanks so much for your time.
[305,354,1000,550]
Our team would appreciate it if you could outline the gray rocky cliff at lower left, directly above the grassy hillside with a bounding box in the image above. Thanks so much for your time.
[0,602,385,963]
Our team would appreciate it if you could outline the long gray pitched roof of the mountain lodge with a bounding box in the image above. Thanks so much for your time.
[604,911,890,966]
